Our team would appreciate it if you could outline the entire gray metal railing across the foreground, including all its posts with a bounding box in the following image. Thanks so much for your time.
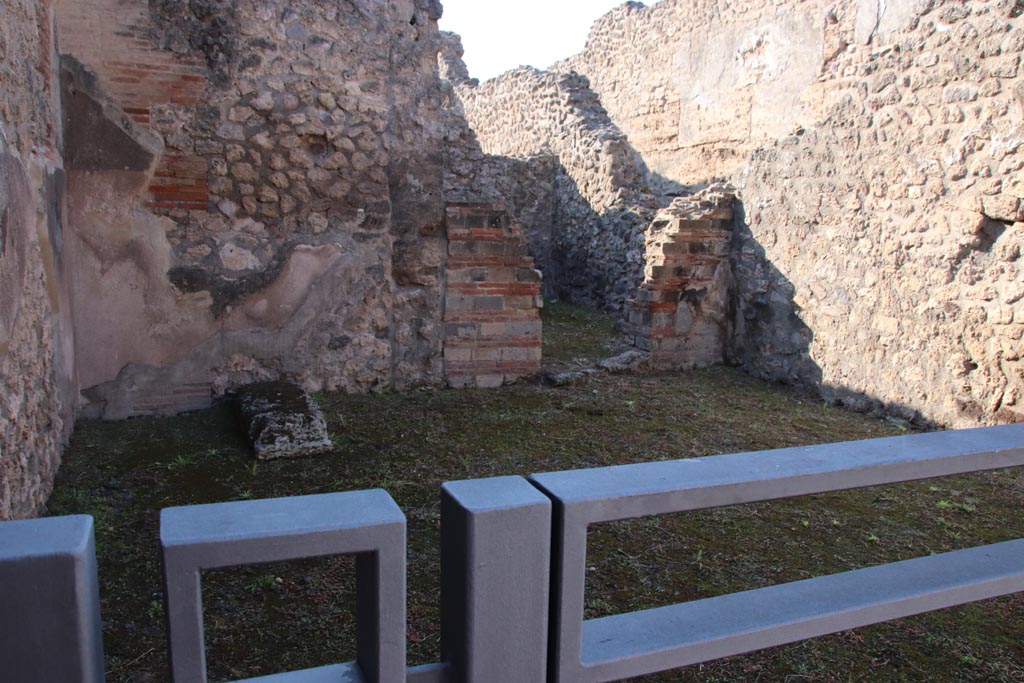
[0,424,1024,683]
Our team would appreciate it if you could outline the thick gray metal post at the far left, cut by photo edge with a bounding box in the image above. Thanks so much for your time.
[0,515,103,683]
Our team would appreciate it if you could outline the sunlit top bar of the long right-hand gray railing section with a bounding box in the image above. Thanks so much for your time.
[530,424,1024,523]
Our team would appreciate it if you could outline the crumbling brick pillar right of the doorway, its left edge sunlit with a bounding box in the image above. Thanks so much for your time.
[628,188,734,370]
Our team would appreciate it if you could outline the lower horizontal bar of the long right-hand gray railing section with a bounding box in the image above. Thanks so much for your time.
[583,540,1024,681]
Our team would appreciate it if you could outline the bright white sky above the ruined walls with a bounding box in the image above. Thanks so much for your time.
[438,0,634,81]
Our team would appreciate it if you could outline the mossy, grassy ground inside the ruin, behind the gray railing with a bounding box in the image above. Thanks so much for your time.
[44,369,1024,683]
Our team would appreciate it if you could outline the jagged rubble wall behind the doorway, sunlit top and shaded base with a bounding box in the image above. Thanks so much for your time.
[450,66,654,313]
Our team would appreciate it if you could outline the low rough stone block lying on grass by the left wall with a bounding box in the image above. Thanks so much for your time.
[238,382,332,460]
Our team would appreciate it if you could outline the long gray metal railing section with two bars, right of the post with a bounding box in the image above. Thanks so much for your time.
[531,424,1024,683]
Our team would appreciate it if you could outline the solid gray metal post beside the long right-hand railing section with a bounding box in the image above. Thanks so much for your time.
[441,476,551,683]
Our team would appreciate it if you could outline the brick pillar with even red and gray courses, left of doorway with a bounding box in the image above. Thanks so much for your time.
[444,204,544,387]
